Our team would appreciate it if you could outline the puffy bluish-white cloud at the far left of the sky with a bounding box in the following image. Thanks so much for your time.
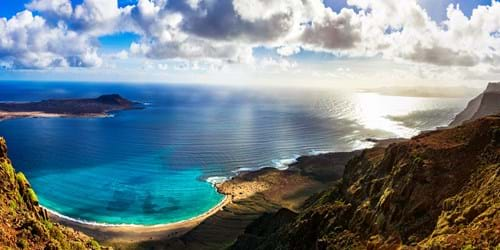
[0,10,102,68]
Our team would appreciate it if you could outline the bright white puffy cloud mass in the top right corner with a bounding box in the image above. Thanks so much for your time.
[348,0,500,67]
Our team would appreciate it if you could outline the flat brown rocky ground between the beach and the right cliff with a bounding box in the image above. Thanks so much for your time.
[111,151,360,250]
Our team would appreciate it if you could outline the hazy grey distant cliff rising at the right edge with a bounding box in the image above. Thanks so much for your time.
[450,82,500,127]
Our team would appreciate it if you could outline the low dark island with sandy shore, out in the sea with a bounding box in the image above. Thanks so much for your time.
[0,94,143,120]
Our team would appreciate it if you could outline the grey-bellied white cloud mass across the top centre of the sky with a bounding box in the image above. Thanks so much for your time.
[127,0,360,63]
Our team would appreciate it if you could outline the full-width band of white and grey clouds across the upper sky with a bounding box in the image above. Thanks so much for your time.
[0,0,500,69]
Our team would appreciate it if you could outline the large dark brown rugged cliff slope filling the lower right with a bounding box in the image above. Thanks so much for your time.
[233,116,500,249]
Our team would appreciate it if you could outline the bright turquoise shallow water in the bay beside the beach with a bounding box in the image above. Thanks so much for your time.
[35,150,222,225]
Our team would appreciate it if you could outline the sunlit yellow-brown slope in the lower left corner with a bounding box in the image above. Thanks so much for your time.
[0,137,100,249]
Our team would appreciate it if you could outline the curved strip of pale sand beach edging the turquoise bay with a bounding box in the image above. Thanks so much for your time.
[46,195,231,243]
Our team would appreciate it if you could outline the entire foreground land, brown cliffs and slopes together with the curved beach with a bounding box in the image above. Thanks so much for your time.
[0,84,500,250]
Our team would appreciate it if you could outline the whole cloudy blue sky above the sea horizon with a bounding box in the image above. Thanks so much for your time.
[0,0,500,88]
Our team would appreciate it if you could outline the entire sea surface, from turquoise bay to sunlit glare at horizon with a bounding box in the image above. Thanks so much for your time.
[0,82,466,225]
